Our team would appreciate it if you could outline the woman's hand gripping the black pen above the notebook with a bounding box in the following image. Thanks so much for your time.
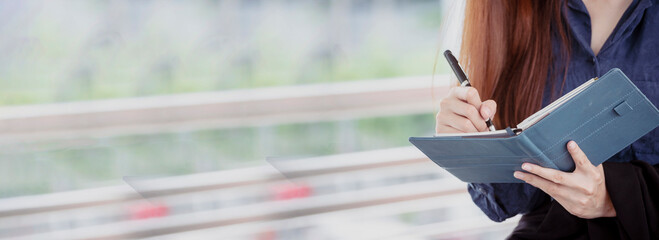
[435,87,497,133]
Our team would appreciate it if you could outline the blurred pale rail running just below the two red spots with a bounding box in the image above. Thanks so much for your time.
[10,179,466,239]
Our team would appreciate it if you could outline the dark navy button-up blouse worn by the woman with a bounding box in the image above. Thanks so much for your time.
[468,0,659,222]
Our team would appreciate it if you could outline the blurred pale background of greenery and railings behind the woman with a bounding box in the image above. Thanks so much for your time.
[0,0,517,240]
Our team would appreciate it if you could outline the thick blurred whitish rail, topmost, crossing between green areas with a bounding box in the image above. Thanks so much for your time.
[0,75,449,142]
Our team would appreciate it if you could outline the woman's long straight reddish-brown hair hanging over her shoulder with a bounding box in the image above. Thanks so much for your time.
[460,0,569,128]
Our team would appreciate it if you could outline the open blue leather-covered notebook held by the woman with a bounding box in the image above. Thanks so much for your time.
[409,68,659,183]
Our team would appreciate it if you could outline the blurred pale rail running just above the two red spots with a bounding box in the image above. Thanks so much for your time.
[0,147,430,217]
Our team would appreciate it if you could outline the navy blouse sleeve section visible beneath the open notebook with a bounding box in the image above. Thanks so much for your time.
[468,183,549,222]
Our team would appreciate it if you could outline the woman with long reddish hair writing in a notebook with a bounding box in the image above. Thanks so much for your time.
[436,0,659,239]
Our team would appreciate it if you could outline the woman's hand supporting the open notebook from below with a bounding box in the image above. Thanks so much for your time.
[514,141,616,219]
